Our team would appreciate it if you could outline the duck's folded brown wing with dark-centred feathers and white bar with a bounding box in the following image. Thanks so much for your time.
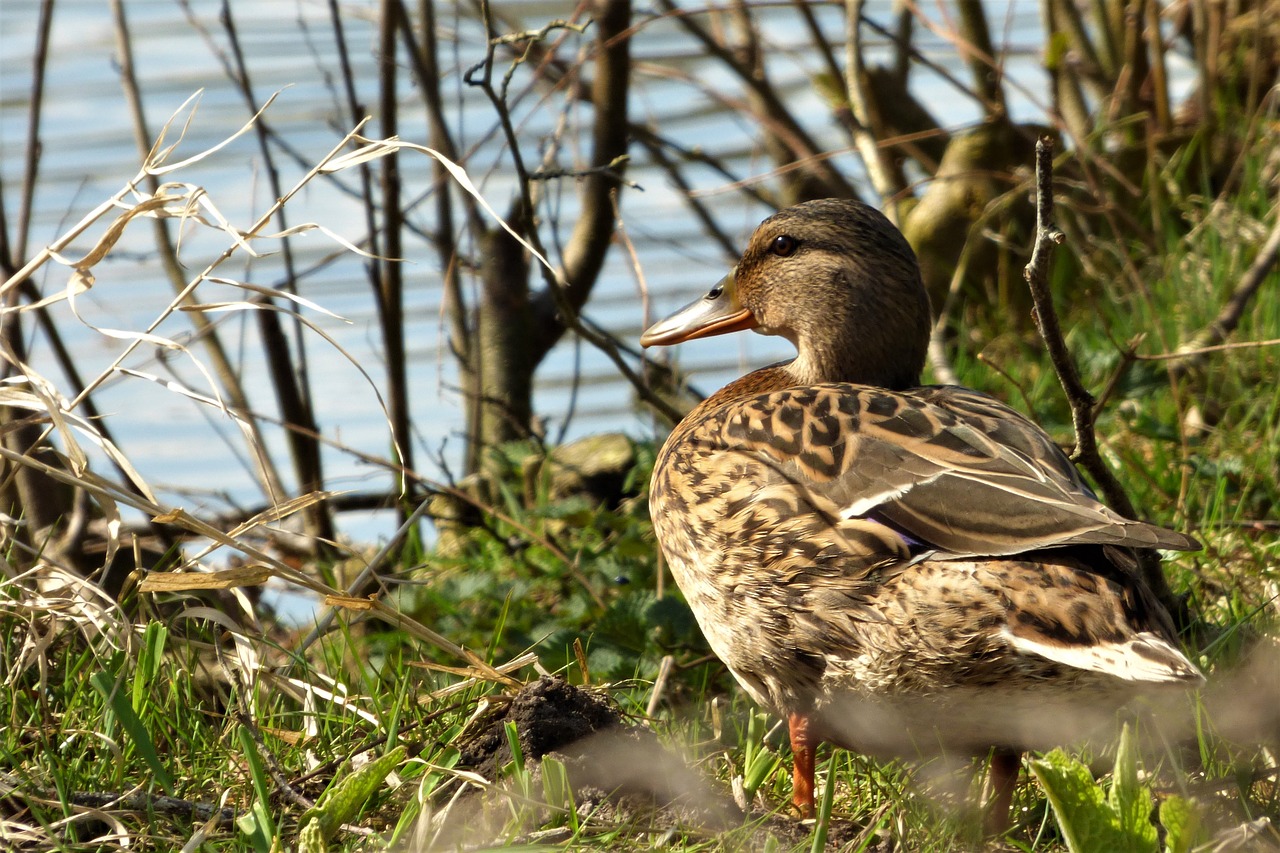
[704,384,1201,557]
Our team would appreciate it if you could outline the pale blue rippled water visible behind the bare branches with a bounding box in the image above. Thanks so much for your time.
[0,0,1141,550]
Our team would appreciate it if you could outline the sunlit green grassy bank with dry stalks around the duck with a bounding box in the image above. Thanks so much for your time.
[0,137,1280,853]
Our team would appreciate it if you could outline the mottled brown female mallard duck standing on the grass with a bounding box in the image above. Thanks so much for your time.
[640,200,1202,829]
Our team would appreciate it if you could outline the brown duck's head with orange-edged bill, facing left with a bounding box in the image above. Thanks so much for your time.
[640,199,929,389]
